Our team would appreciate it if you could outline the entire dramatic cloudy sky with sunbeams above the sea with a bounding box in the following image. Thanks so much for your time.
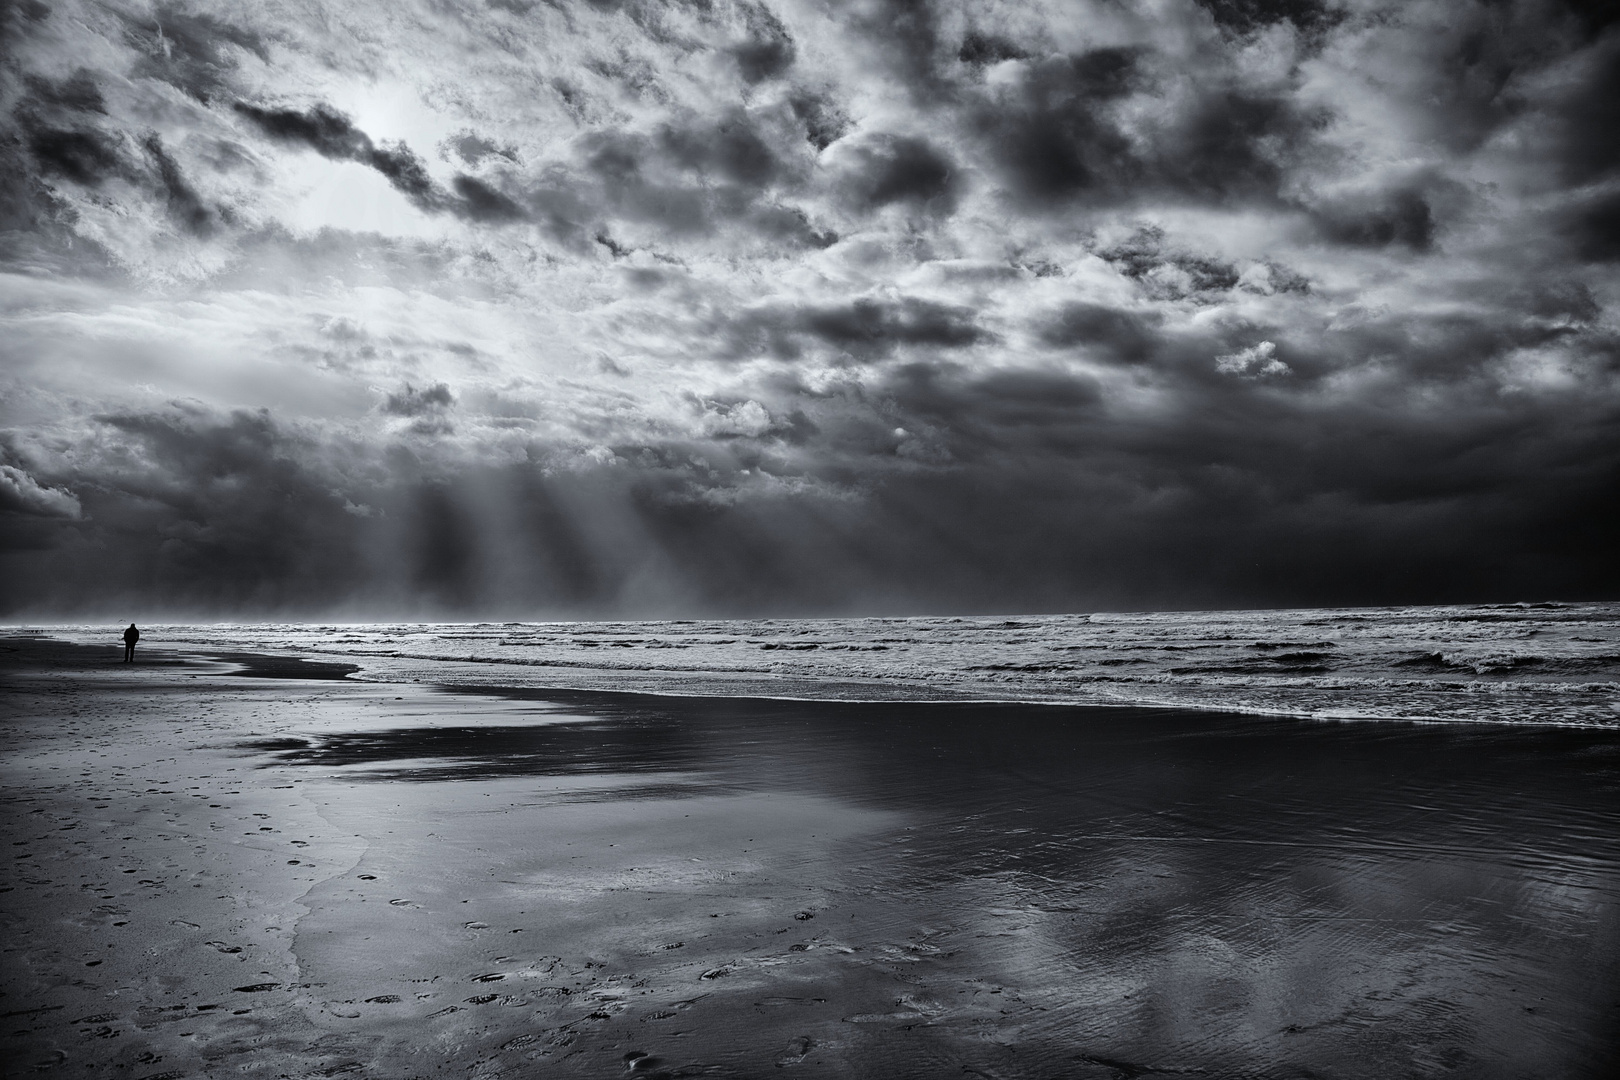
[0,0,1620,617]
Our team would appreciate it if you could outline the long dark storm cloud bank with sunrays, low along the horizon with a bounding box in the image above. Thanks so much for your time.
[0,346,1620,612]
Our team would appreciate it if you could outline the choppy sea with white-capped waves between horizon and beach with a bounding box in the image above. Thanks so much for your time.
[28,602,1620,727]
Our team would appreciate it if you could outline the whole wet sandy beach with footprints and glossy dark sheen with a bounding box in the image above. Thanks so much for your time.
[0,640,1620,1080]
